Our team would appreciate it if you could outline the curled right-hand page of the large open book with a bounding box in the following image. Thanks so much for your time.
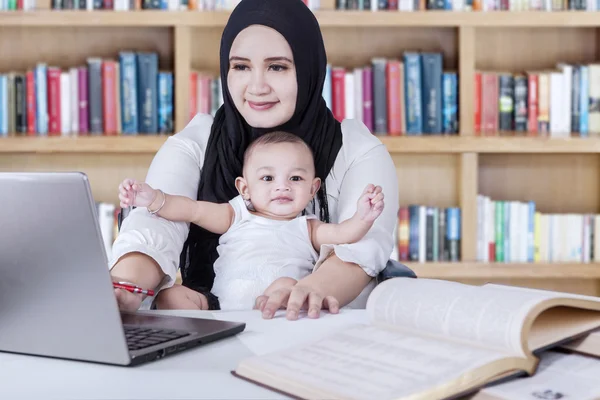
[367,278,584,356]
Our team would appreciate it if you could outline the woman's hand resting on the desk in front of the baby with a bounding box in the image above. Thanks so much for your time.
[256,278,340,320]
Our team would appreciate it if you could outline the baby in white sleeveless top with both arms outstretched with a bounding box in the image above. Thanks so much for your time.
[119,131,384,310]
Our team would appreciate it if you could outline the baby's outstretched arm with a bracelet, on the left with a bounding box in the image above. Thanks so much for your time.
[119,179,233,234]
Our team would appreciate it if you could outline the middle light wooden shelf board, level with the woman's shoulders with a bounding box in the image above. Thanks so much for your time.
[0,135,600,154]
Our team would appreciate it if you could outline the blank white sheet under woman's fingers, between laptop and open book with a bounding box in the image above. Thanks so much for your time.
[213,309,368,355]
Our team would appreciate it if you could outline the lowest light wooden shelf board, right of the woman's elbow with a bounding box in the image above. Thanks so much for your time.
[406,262,600,279]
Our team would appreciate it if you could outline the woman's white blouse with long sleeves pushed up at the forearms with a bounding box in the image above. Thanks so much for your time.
[109,114,399,304]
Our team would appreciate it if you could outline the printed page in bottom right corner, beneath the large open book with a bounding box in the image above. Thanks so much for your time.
[473,351,600,400]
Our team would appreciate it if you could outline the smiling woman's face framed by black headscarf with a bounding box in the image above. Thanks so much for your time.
[227,25,298,128]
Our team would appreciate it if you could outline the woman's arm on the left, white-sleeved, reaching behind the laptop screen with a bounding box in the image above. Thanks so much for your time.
[109,114,212,309]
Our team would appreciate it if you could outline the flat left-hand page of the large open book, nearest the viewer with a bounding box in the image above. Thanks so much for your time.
[236,325,527,400]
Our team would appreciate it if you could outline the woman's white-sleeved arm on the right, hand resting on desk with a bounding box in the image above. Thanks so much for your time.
[263,121,399,319]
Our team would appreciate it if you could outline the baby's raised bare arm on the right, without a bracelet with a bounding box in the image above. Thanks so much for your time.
[309,184,384,251]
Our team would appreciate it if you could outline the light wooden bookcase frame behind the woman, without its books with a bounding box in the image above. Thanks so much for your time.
[0,4,600,294]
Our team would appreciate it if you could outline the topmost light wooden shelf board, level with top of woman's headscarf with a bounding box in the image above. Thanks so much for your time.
[0,10,600,28]
